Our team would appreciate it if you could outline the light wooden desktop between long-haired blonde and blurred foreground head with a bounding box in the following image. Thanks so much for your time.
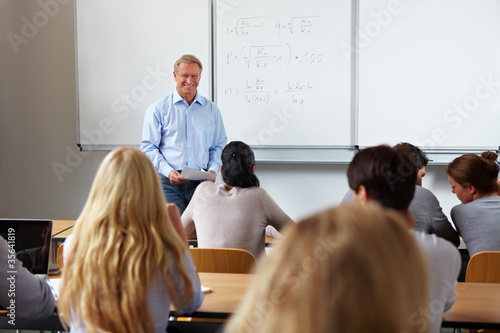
[170,273,254,319]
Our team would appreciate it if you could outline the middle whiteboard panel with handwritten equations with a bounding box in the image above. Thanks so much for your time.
[215,0,352,147]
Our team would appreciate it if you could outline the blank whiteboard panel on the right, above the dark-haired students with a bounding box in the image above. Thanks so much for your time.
[358,0,500,150]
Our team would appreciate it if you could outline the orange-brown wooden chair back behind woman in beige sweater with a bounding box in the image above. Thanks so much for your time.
[189,247,257,273]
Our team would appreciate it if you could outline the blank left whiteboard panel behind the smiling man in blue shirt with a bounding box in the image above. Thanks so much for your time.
[75,0,212,150]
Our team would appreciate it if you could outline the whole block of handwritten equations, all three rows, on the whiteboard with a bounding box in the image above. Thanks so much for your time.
[218,16,332,109]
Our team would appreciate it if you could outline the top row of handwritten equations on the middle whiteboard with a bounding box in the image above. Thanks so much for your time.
[226,16,321,37]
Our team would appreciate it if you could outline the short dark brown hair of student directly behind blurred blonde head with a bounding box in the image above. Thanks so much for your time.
[347,145,417,211]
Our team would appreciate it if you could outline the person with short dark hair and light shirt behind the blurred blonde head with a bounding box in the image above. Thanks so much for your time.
[347,146,461,333]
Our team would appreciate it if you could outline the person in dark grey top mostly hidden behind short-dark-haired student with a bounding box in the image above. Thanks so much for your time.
[342,142,460,246]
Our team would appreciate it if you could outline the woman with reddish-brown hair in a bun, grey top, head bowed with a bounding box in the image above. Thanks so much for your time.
[446,153,500,256]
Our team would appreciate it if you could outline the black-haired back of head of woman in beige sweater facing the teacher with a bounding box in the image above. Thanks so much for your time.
[221,141,260,188]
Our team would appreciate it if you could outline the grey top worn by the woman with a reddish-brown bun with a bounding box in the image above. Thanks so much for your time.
[451,195,500,257]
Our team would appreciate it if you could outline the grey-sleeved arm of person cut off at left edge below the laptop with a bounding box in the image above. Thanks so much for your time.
[0,236,55,322]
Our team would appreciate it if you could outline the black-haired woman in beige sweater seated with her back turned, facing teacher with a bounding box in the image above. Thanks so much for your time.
[181,141,291,257]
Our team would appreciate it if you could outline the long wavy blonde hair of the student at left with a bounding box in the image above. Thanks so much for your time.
[58,147,193,332]
